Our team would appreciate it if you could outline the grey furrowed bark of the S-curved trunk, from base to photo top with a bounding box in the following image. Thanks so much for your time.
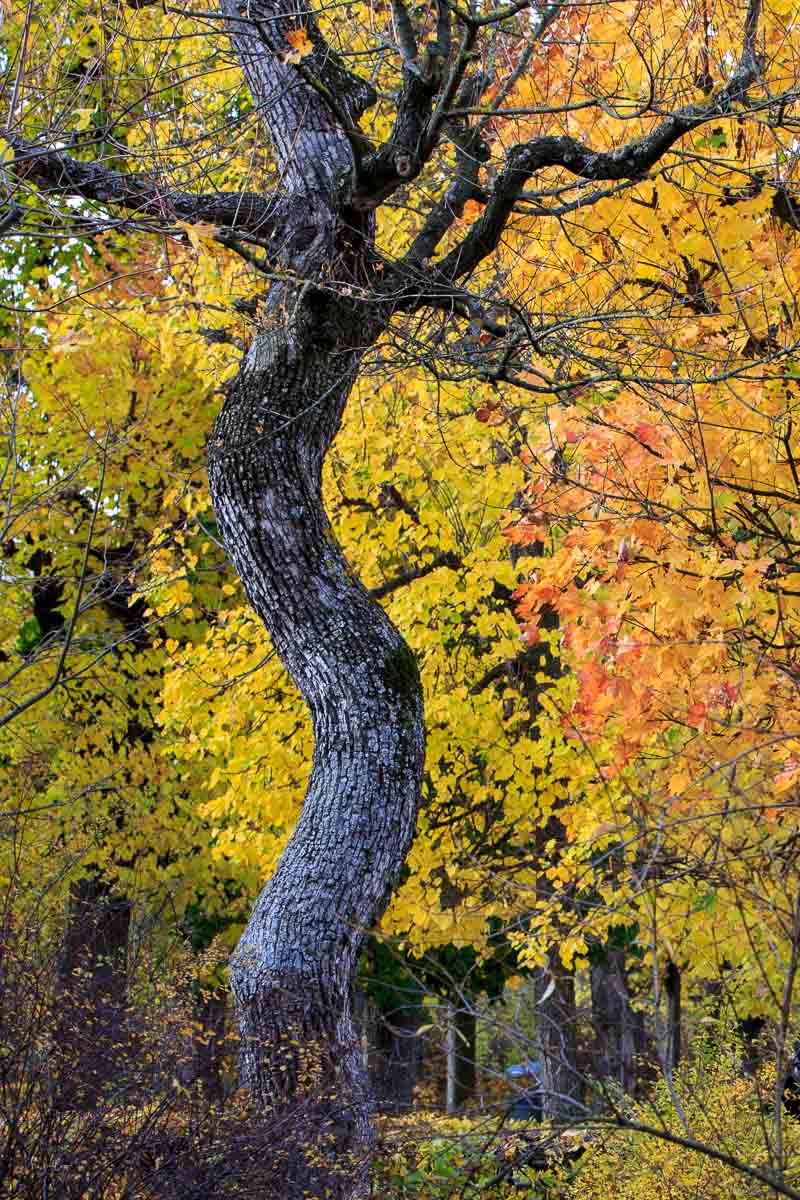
[196,7,425,1196]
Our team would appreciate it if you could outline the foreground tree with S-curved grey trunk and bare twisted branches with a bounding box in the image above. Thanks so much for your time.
[4,0,795,1195]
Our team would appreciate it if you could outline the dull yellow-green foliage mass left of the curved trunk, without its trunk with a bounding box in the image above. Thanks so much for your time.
[0,242,250,936]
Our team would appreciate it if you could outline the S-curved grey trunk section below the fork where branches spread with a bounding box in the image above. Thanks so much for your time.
[209,307,423,1195]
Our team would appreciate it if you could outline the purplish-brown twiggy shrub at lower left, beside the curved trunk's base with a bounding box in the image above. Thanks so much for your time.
[0,894,357,1200]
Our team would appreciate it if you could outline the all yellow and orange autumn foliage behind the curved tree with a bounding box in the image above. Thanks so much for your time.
[0,0,800,1200]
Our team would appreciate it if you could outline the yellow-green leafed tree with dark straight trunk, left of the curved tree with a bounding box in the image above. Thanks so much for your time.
[0,244,250,1106]
